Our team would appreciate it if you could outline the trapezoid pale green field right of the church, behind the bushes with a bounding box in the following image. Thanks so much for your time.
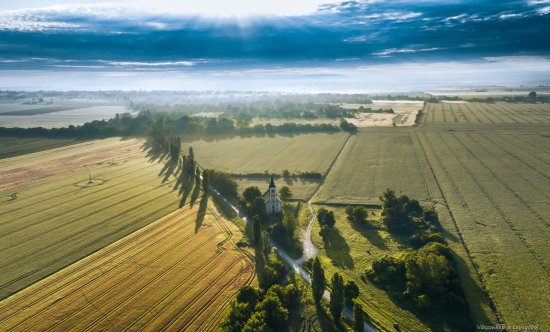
[317,128,441,203]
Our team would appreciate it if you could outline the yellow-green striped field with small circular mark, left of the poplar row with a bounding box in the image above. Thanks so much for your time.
[0,139,182,298]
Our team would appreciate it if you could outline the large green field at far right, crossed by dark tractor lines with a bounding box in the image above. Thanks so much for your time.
[418,130,550,326]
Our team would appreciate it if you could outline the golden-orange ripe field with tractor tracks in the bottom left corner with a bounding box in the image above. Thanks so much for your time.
[0,200,254,331]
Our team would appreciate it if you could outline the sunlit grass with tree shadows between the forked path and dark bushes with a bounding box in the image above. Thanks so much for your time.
[312,205,480,331]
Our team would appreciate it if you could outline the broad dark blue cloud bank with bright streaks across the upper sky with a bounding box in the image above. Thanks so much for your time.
[0,0,550,71]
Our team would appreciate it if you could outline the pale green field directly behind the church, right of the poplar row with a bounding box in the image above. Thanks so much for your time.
[183,133,348,174]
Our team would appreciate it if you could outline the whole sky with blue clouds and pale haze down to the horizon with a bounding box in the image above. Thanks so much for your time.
[0,0,550,92]
